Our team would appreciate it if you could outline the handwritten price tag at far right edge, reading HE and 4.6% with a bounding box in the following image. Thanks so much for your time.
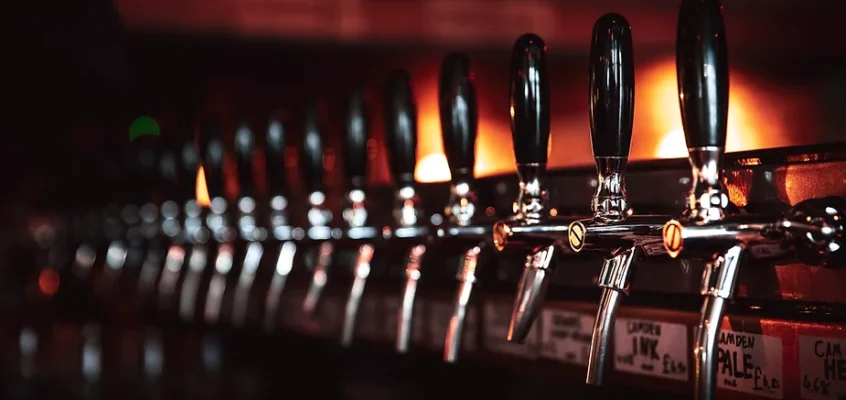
[799,335,846,400]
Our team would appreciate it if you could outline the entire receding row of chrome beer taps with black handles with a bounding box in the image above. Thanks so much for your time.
[24,0,846,400]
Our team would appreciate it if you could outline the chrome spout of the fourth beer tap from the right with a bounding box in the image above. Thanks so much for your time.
[444,245,484,363]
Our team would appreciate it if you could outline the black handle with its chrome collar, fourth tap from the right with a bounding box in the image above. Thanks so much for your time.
[438,53,479,226]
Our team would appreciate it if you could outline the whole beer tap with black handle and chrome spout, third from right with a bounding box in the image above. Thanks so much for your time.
[493,34,567,343]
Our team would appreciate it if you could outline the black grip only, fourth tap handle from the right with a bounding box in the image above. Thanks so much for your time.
[438,54,479,181]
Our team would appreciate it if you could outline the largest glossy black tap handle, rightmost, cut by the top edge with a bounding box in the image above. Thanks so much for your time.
[676,0,729,148]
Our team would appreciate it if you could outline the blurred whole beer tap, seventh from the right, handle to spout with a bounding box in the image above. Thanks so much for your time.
[300,103,334,316]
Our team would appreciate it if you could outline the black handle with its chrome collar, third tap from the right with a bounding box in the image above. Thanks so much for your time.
[510,34,549,222]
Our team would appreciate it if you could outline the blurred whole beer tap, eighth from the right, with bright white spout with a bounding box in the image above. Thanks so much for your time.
[264,118,297,331]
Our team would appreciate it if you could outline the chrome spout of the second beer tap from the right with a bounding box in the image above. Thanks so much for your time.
[585,245,643,385]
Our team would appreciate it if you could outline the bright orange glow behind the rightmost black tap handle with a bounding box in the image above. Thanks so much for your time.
[644,60,785,159]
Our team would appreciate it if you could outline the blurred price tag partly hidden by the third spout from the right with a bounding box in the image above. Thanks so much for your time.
[484,301,540,359]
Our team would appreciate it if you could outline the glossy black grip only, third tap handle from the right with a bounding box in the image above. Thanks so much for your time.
[510,33,549,166]
